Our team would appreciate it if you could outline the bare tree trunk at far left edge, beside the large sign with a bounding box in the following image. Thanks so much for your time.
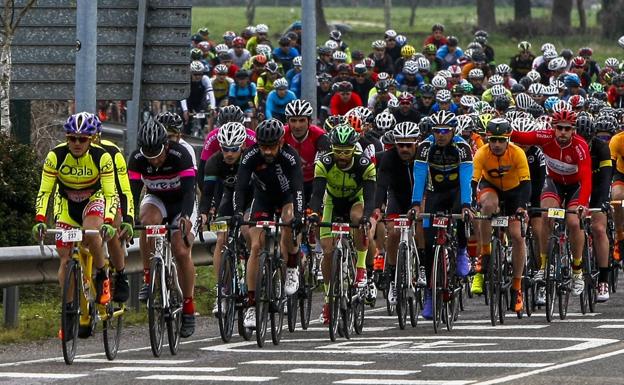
[0,0,37,135]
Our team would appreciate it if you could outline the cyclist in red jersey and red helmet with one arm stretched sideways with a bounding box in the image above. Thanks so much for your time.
[511,110,592,295]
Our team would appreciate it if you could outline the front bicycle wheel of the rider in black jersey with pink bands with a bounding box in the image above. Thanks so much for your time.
[147,258,165,357]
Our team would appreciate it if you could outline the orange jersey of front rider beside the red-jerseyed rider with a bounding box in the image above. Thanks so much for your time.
[472,143,531,191]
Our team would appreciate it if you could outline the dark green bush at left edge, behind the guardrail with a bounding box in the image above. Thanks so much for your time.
[0,134,41,247]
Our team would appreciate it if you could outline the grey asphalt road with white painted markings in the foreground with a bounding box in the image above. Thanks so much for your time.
[0,285,624,385]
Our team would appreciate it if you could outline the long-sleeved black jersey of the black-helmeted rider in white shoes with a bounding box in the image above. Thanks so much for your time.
[234,144,303,215]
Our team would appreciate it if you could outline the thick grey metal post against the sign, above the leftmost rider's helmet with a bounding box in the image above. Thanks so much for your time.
[74,0,97,113]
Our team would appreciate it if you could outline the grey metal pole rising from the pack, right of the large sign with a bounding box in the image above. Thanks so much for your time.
[301,0,316,120]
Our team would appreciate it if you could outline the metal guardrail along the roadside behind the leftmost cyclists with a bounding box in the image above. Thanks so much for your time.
[0,231,217,327]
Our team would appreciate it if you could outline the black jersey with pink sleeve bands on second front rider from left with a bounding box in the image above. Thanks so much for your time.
[128,142,195,218]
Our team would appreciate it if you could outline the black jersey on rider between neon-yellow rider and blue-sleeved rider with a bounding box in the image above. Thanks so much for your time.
[375,147,414,214]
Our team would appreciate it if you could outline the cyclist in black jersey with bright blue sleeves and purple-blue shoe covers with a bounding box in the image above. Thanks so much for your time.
[411,111,472,319]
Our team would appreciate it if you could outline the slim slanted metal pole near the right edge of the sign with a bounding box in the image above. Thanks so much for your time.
[124,0,147,156]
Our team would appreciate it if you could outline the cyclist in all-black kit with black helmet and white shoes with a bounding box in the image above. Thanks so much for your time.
[231,119,304,327]
